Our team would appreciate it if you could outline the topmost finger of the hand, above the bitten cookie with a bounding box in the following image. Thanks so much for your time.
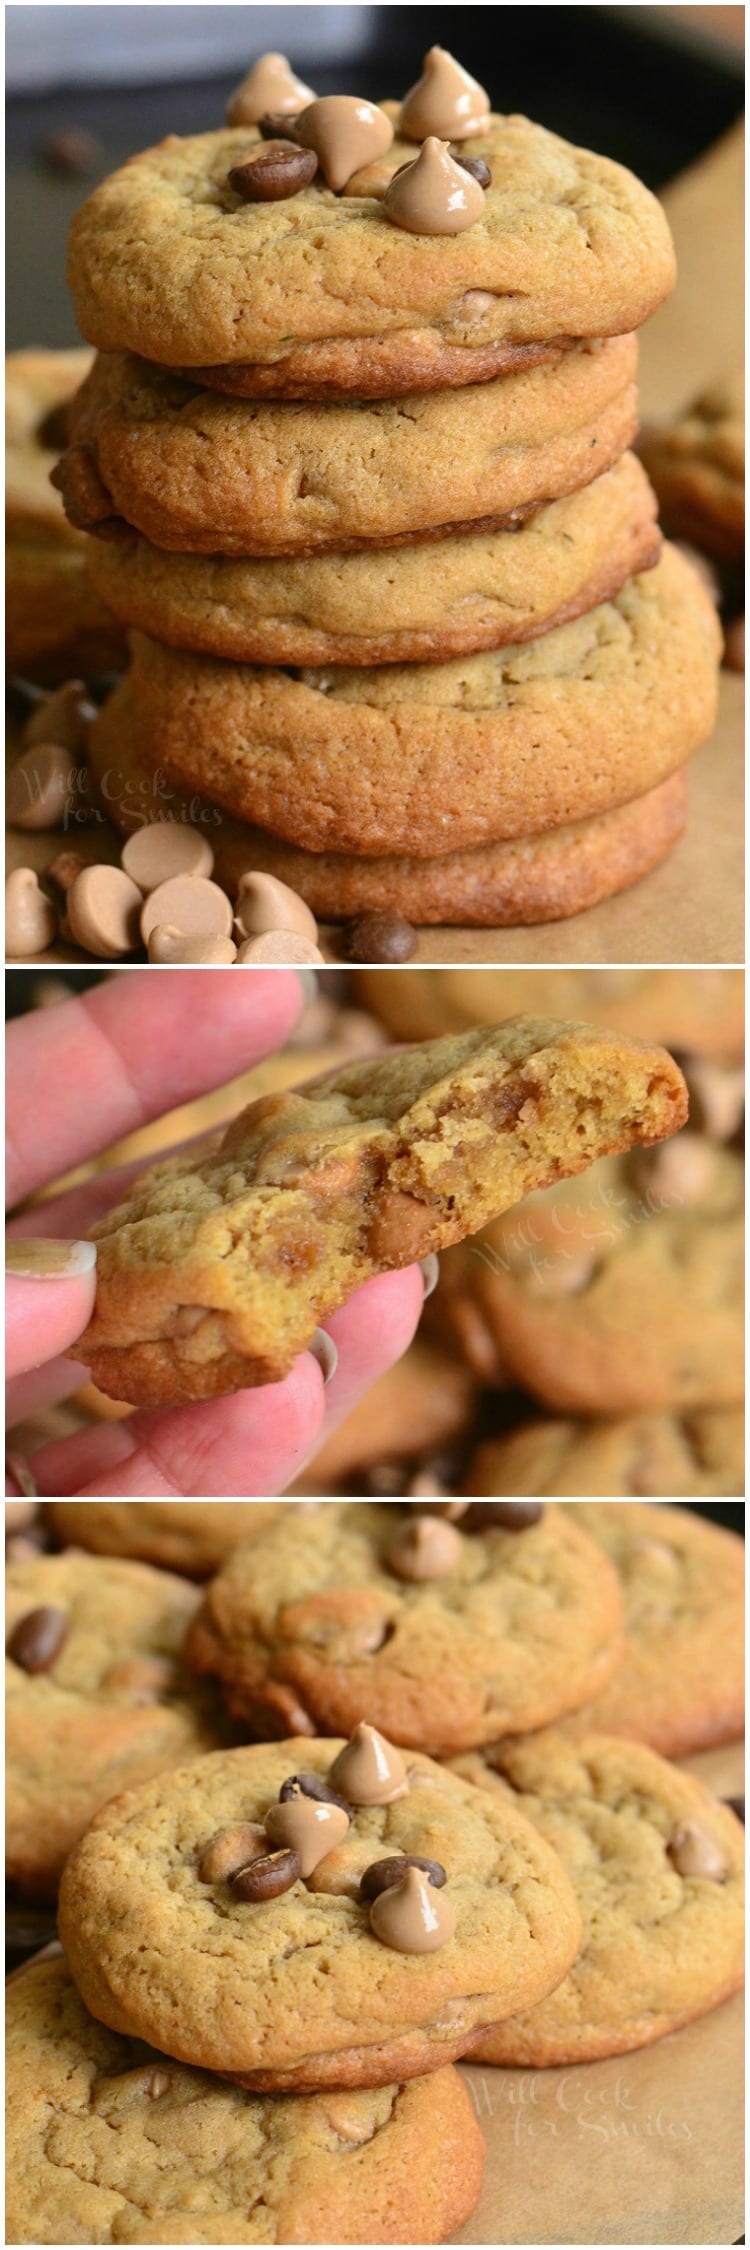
[7,968,304,1204]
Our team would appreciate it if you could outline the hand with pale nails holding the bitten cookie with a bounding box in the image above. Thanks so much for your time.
[7,968,423,1499]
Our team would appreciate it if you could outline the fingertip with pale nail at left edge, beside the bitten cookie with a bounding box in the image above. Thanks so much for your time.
[5,1235,97,1375]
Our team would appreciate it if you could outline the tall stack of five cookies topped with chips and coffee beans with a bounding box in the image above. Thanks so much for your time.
[59,47,718,925]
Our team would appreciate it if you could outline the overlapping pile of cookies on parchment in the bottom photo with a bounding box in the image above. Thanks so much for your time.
[7,1503,743,2243]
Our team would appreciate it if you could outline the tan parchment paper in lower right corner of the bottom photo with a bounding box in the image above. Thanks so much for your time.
[450,1744,743,2246]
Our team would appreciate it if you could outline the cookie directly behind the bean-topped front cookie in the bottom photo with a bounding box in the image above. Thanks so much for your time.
[185,1501,622,1755]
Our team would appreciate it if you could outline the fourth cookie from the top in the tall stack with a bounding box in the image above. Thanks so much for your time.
[92,549,718,860]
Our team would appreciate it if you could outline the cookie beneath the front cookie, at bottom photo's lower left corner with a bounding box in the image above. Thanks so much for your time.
[7,1955,484,2243]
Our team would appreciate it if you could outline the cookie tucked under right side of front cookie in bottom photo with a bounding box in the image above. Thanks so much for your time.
[450,1728,745,2070]
